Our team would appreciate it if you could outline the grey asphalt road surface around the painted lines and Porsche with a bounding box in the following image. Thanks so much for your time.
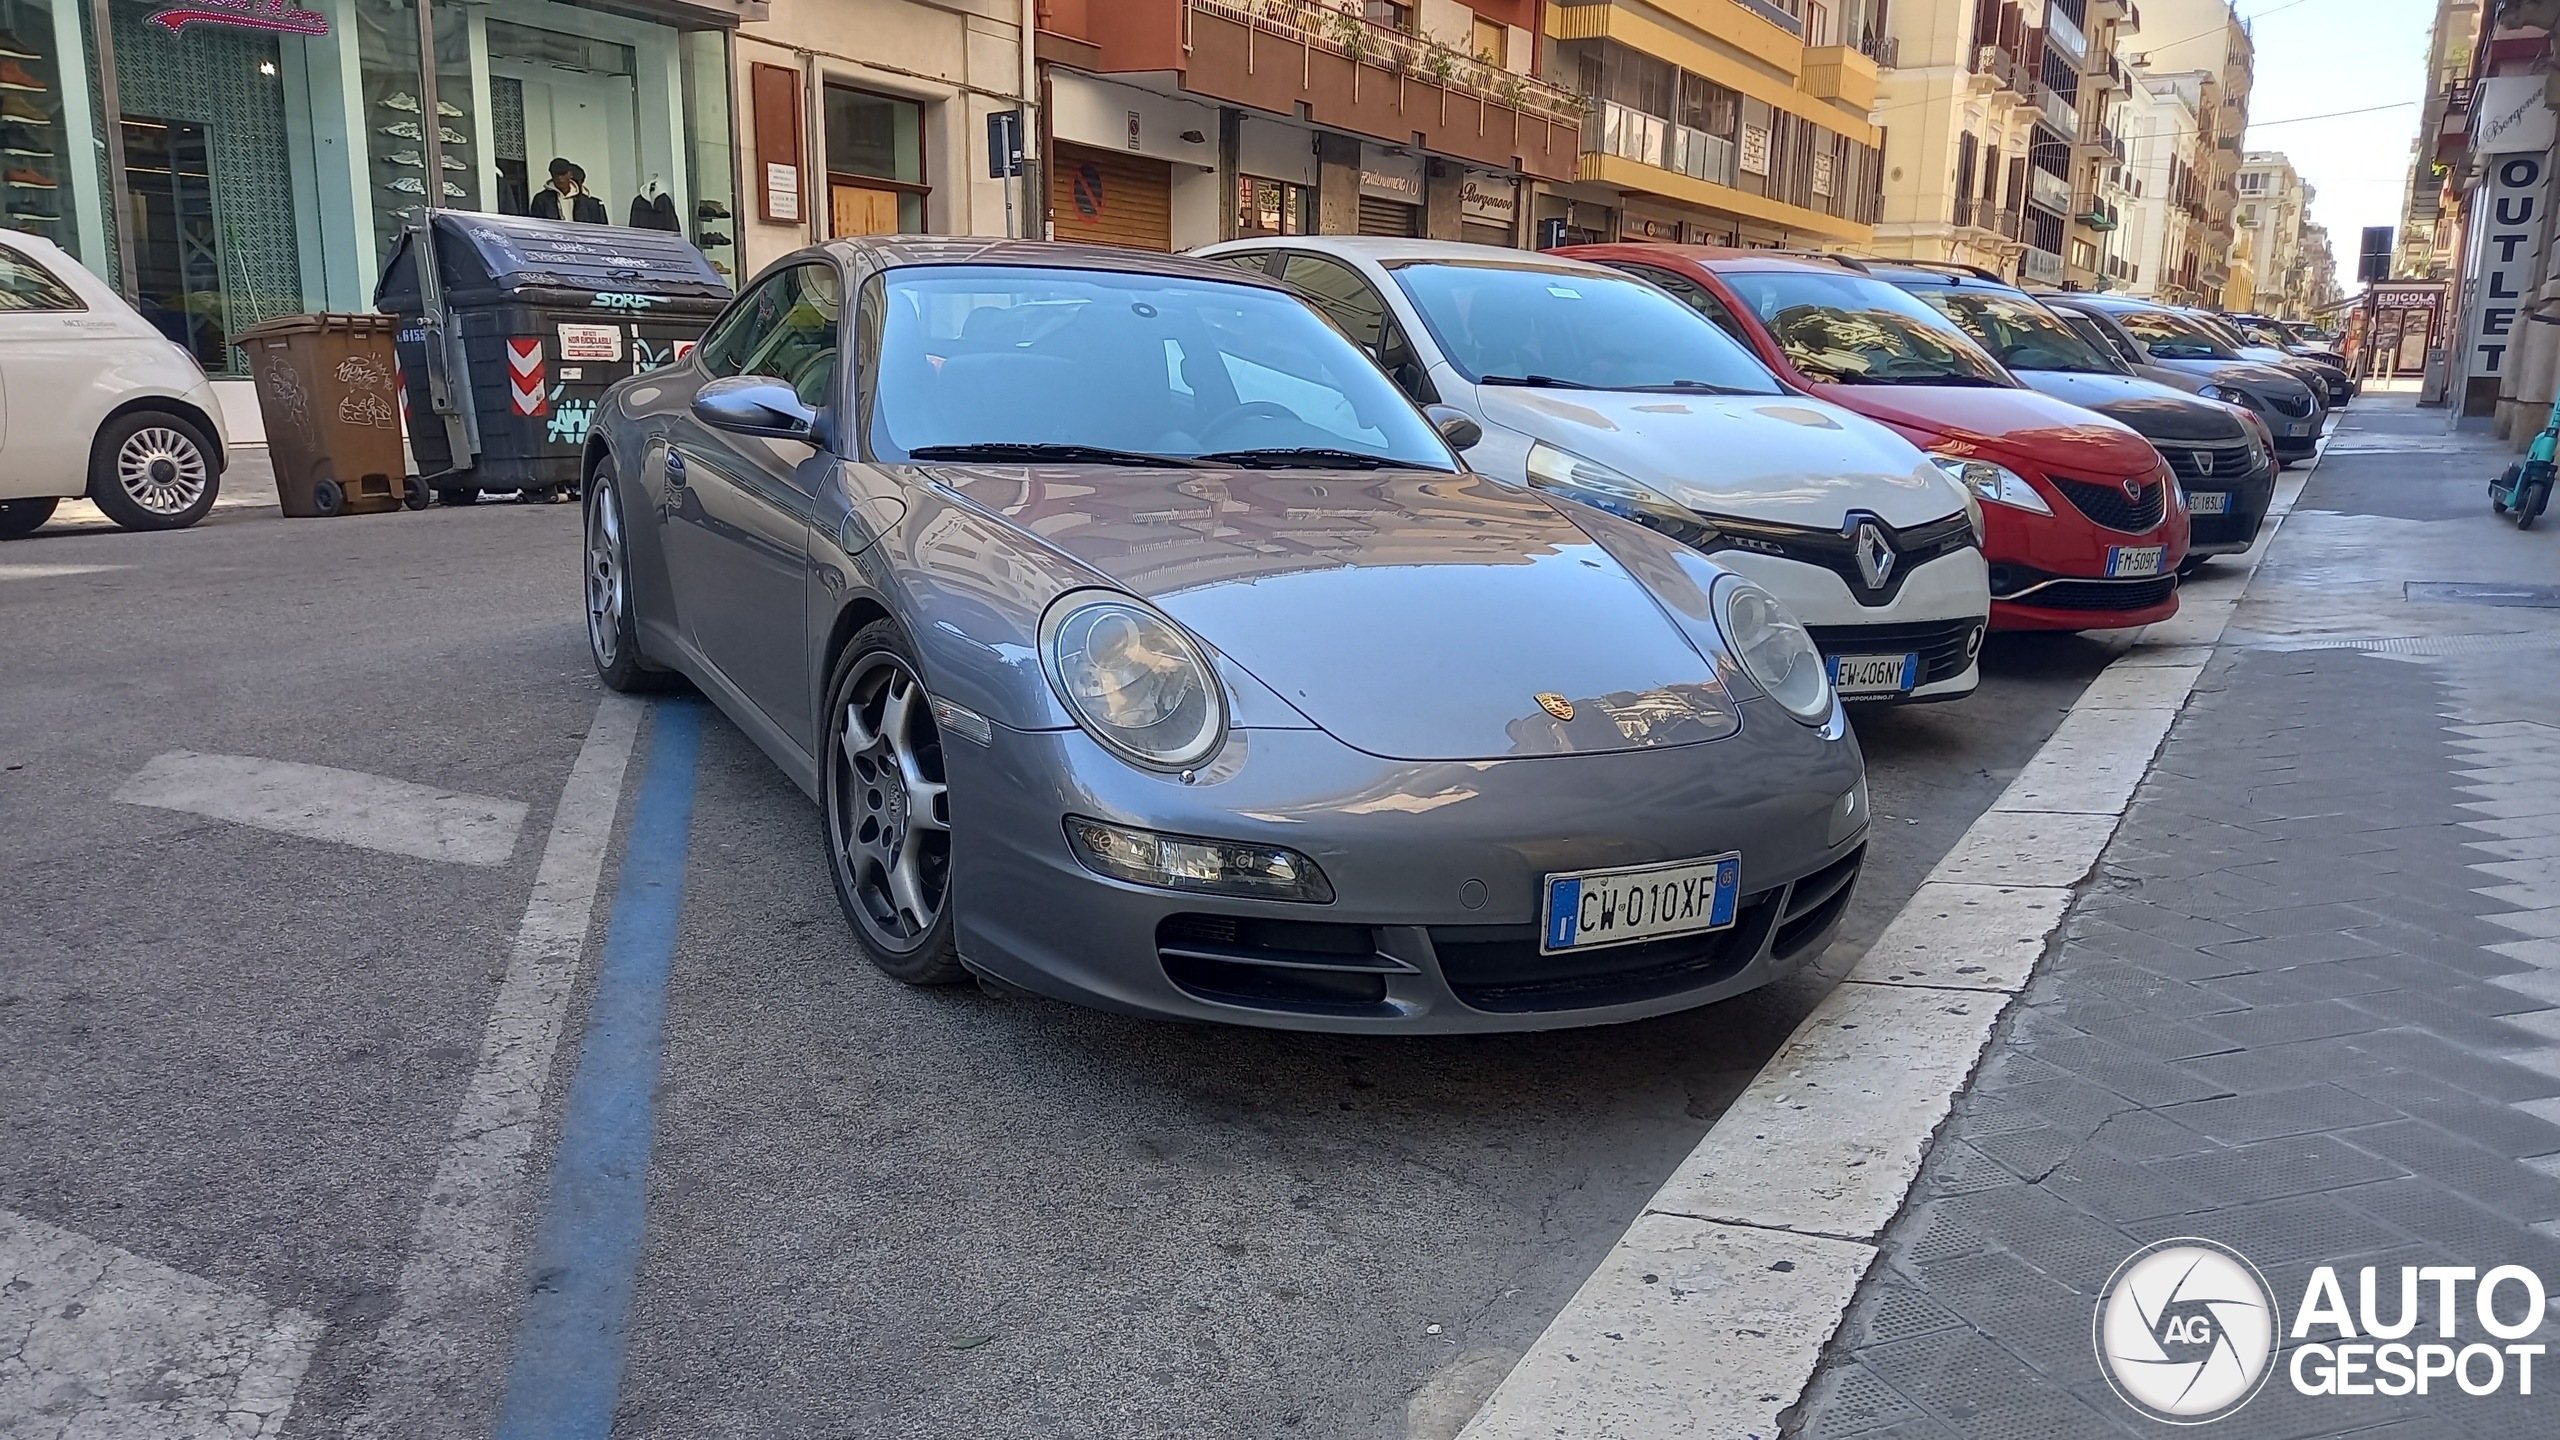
[0,482,2109,1440]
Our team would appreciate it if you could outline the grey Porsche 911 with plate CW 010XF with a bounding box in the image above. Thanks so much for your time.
[584,241,1866,1033]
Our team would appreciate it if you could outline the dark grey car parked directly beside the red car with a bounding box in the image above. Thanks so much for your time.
[1869,261,2276,569]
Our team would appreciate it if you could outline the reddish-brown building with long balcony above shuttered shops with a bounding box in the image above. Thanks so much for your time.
[1034,0,1585,251]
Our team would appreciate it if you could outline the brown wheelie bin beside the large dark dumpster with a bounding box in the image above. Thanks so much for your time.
[236,315,407,515]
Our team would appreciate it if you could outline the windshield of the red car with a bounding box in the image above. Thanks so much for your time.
[1718,269,2010,387]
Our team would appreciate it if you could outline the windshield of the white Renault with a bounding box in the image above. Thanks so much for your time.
[1395,261,1779,395]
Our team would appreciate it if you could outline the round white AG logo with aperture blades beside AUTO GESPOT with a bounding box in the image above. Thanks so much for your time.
[2094,1240,2278,1425]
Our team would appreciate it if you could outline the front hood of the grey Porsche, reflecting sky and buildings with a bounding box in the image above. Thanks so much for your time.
[927,466,1738,761]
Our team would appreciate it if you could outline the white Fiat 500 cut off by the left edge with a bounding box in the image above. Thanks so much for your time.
[0,231,225,541]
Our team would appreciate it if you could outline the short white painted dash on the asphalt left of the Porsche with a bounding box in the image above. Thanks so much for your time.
[115,751,525,866]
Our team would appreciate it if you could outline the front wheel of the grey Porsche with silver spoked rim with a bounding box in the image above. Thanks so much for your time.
[817,620,970,984]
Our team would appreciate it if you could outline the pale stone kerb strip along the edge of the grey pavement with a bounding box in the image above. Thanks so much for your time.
[1459,435,2334,1440]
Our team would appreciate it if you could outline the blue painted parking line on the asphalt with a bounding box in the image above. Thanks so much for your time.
[497,702,701,1440]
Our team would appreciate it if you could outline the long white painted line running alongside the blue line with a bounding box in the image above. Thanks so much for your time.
[348,694,645,1435]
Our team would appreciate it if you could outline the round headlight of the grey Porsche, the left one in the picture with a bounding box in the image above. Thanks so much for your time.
[1039,592,1226,769]
